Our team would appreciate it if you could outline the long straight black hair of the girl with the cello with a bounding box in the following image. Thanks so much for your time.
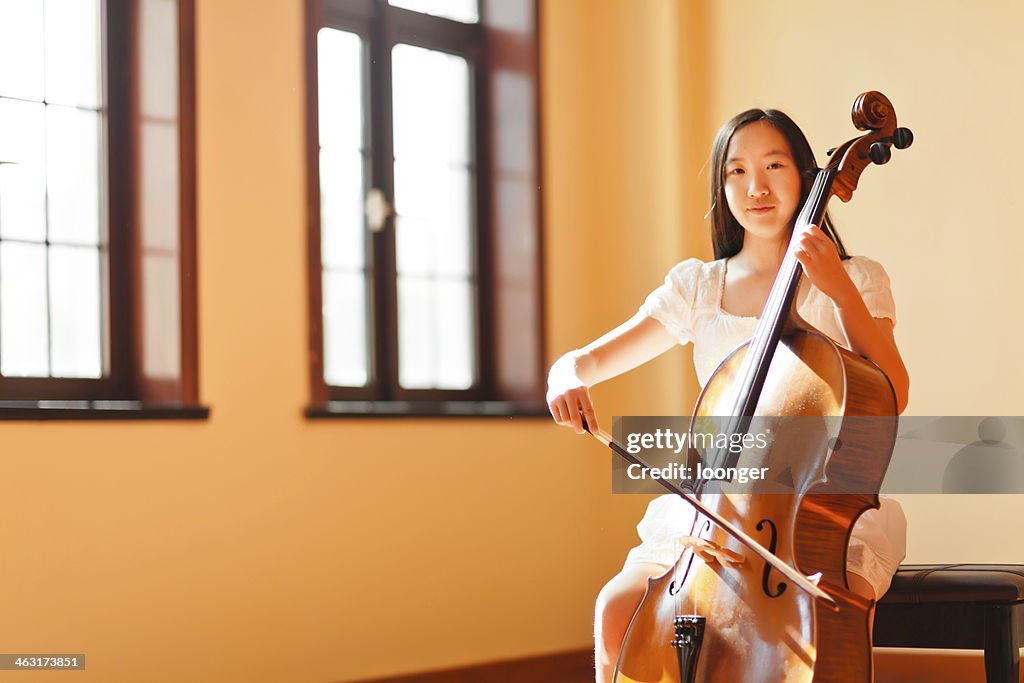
[709,109,850,260]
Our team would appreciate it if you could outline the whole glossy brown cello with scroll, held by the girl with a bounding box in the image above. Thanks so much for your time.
[595,91,913,683]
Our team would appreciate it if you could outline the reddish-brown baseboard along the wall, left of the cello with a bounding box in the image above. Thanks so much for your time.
[350,650,594,683]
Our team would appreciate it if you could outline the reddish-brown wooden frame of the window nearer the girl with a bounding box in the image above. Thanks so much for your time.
[306,0,547,417]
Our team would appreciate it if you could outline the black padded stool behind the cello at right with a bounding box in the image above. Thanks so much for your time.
[873,564,1024,683]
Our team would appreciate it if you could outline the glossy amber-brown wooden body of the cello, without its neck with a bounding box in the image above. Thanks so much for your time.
[615,329,896,683]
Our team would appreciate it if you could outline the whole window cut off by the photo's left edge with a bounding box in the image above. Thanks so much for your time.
[0,0,206,417]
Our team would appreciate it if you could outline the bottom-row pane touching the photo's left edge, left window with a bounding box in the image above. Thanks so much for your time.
[0,242,49,377]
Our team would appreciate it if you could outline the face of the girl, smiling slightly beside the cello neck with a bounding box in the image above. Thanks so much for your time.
[724,121,800,240]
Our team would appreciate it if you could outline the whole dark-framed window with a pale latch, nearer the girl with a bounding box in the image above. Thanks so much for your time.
[307,0,543,416]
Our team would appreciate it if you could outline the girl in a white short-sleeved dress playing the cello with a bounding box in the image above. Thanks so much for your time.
[547,110,909,683]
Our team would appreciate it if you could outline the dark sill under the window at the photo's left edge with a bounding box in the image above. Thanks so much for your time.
[0,400,210,420]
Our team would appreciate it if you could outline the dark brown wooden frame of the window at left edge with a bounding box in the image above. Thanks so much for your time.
[0,0,209,420]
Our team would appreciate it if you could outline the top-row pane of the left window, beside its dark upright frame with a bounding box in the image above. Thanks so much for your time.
[44,0,99,109]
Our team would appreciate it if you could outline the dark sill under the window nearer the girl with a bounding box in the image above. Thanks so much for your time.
[305,400,551,419]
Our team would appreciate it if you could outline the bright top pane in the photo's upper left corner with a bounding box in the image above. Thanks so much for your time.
[0,0,44,101]
